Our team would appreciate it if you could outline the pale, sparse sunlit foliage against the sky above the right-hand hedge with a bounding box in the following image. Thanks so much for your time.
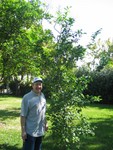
[86,36,113,71]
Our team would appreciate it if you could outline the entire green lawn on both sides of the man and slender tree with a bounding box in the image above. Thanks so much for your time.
[0,96,113,150]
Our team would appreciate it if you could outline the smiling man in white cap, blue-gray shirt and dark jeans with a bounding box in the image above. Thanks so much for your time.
[20,77,48,150]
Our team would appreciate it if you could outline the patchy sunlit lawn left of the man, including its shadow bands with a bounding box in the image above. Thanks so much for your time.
[0,97,22,150]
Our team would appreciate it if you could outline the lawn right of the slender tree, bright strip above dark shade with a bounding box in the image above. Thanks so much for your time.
[83,104,113,150]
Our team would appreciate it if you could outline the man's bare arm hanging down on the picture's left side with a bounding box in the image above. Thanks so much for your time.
[20,116,27,141]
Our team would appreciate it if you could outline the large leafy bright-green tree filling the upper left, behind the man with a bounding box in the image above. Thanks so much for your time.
[0,0,51,94]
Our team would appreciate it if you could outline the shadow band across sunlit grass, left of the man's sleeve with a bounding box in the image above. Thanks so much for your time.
[0,108,20,121]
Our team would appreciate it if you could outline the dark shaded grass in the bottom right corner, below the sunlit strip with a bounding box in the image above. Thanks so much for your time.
[81,118,113,150]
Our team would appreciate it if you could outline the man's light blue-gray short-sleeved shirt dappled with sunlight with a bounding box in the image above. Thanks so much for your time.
[21,91,46,137]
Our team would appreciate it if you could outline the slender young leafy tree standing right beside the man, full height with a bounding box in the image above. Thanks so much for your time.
[46,10,93,150]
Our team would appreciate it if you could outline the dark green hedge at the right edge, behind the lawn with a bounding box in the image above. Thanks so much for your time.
[84,68,113,104]
